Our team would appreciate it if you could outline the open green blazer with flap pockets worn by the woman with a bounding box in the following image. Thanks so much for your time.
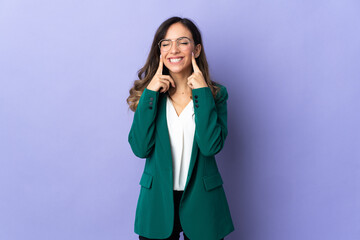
[128,85,234,240]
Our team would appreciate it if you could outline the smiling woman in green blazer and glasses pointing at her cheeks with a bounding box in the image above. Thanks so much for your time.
[127,17,234,240]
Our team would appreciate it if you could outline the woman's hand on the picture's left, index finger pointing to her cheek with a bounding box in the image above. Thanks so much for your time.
[146,55,175,93]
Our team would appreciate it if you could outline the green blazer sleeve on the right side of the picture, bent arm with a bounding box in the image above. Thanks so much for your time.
[192,85,228,156]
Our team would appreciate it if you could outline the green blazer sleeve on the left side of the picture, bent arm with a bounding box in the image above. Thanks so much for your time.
[128,88,159,158]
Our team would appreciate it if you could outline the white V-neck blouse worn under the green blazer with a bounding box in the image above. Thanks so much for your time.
[166,96,195,191]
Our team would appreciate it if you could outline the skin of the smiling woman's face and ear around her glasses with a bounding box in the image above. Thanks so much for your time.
[160,23,201,73]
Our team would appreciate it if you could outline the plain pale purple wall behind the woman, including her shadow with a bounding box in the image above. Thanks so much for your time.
[0,0,360,240]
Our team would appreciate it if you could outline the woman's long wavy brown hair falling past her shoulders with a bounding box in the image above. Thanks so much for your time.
[126,17,220,112]
